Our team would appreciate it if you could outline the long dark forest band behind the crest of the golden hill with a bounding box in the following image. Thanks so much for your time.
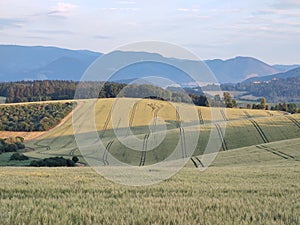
[0,80,208,106]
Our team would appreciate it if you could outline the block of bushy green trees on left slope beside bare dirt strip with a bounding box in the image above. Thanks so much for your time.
[0,103,73,131]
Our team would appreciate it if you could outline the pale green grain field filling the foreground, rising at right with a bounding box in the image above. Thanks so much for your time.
[0,139,300,225]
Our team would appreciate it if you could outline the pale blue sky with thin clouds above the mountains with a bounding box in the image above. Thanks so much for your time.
[0,0,300,64]
